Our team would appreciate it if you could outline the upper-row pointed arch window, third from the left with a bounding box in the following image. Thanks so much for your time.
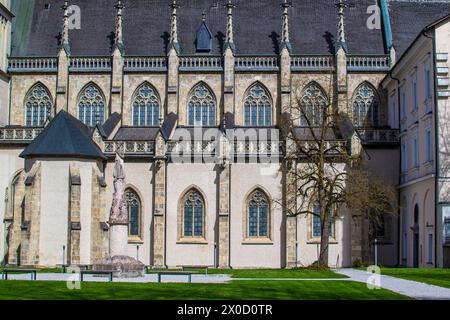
[132,83,160,127]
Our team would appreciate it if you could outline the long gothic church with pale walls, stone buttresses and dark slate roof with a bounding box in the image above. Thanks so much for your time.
[0,0,449,268]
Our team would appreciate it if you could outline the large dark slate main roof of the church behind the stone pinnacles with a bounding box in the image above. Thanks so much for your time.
[12,0,385,56]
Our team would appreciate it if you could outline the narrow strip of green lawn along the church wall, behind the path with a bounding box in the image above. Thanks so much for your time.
[149,268,347,279]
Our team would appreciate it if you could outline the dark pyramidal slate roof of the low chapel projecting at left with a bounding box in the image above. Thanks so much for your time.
[20,111,106,159]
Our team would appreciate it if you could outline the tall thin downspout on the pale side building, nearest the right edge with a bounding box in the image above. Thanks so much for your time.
[422,30,440,268]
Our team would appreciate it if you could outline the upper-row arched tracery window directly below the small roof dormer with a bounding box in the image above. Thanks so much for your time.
[188,82,217,127]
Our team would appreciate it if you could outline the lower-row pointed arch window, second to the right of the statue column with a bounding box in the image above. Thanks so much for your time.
[183,189,205,238]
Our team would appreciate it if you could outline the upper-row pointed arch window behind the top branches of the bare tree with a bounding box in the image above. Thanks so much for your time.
[300,83,328,127]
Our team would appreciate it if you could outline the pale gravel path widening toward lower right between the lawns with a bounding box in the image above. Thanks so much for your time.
[335,269,450,300]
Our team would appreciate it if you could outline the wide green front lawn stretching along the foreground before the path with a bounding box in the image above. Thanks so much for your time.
[0,280,407,300]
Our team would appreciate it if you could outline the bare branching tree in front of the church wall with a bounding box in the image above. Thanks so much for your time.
[281,77,396,267]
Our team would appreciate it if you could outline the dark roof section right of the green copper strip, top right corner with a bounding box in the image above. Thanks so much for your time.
[389,1,450,57]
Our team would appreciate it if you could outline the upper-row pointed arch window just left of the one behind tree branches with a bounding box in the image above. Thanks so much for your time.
[244,83,272,127]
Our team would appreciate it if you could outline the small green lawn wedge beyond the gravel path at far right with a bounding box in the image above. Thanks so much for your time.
[381,268,450,288]
